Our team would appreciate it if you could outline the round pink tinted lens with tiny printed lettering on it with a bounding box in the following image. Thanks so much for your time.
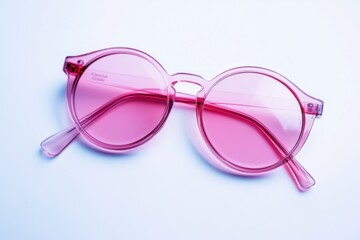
[73,54,168,149]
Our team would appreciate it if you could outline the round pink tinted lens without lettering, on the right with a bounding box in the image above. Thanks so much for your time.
[202,73,302,169]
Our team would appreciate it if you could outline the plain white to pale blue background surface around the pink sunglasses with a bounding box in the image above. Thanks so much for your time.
[0,0,360,240]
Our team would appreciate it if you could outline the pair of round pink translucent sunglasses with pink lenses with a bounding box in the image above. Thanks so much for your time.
[41,48,323,190]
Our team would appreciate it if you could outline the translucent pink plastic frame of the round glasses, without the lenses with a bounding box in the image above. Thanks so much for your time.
[41,48,324,191]
